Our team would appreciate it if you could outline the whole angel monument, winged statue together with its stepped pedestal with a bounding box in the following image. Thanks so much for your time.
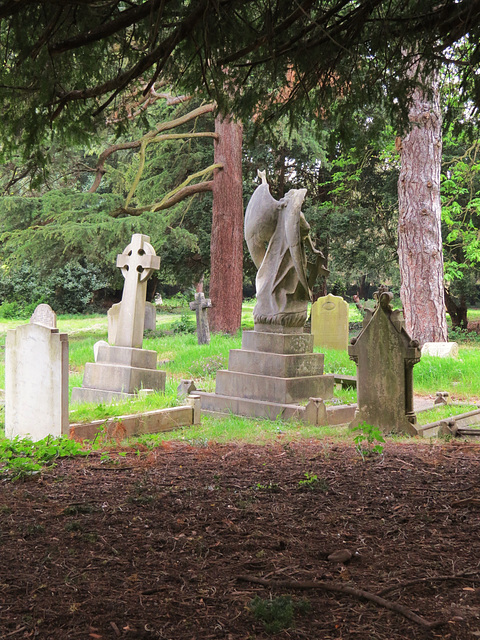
[201,172,334,418]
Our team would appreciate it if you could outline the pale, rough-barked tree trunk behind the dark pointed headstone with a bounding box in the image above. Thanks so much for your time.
[398,61,447,344]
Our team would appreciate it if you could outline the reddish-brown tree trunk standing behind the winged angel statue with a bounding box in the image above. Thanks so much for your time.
[209,115,243,333]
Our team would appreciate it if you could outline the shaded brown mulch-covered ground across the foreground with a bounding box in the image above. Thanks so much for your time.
[0,440,480,640]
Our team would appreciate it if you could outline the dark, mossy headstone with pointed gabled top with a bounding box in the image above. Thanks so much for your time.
[348,292,421,435]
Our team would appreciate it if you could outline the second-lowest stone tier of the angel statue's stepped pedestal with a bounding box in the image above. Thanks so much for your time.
[215,370,334,404]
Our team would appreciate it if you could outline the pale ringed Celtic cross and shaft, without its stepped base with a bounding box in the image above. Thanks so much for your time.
[115,233,160,349]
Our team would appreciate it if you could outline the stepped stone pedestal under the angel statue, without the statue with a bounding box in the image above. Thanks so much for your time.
[197,325,334,419]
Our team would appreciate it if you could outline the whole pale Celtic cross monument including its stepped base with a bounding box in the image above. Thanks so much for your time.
[72,233,166,402]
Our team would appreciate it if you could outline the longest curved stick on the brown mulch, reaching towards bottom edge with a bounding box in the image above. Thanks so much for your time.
[237,576,443,629]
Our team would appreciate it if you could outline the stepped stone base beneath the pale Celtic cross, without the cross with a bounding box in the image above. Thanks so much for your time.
[72,345,166,402]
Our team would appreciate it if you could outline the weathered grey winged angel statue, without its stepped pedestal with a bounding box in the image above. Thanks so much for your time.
[245,171,329,328]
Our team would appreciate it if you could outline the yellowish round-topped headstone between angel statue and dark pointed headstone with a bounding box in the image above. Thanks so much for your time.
[312,293,348,351]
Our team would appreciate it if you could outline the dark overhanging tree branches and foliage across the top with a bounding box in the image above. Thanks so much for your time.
[0,0,480,160]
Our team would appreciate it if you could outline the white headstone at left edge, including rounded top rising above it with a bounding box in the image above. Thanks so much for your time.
[5,305,69,441]
